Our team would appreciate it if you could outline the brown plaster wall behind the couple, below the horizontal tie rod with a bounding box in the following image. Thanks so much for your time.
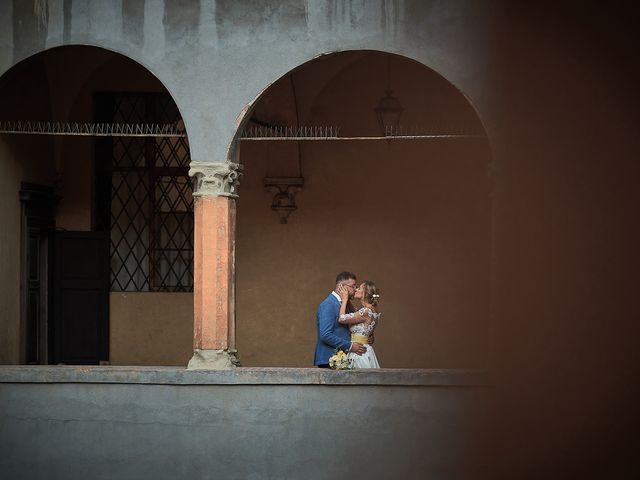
[236,139,490,368]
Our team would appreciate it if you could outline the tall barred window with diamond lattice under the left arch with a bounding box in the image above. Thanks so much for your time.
[96,93,193,292]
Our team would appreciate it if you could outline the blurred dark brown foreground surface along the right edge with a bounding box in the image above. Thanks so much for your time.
[477,2,640,480]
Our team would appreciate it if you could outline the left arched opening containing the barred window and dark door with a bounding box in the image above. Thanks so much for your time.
[0,46,193,365]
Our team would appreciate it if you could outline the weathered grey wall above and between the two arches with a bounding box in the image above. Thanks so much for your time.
[0,0,498,161]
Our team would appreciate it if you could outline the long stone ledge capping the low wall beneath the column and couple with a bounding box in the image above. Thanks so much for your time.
[0,365,488,387]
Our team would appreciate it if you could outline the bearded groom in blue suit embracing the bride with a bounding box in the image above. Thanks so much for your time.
[313,272,367,368]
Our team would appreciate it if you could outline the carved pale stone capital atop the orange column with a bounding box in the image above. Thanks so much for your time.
[189,161,243,198]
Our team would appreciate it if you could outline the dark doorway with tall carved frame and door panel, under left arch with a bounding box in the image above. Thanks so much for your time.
[20,183,109,365]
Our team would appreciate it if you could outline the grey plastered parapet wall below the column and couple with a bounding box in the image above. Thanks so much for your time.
[0,368,486,480]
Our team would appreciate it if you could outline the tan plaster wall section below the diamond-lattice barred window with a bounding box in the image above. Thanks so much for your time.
[109,292,193,366]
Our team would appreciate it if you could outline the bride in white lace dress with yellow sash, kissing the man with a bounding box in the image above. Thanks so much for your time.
[338,280,382,369]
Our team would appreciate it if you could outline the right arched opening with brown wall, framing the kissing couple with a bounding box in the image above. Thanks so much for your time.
[236,51,491,368]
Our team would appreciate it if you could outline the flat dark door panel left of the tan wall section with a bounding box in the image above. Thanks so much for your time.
[49,231,109,365]
